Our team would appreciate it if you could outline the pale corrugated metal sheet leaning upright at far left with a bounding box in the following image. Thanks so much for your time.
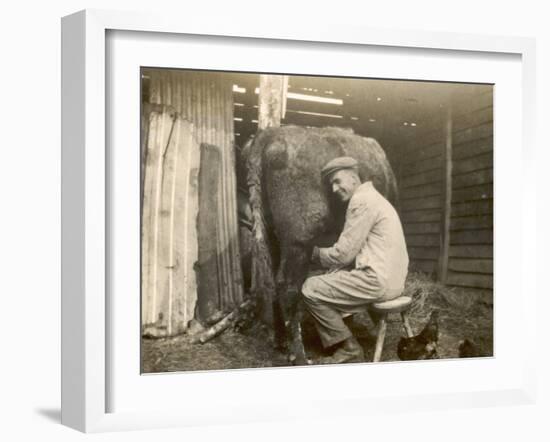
[141,109,200,336]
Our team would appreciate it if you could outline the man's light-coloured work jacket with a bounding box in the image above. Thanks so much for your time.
[319,181,409,291]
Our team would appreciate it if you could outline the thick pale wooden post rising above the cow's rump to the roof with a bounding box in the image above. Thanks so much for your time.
[258,75,288,129]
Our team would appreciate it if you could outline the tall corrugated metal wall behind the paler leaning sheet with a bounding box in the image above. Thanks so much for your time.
[146,69,243,310]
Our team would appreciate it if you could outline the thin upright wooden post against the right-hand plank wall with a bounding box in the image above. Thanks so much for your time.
[438,105,453,284]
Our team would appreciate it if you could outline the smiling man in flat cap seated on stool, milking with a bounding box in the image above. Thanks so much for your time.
[302,157,409,363]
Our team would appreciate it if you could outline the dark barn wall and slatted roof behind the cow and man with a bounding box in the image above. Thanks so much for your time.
[226,74,493,290]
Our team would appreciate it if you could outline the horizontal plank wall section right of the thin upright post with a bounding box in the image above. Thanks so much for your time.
[446,87,493,289]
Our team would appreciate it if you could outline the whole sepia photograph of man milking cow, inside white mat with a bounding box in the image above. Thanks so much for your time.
[140,67,494,374]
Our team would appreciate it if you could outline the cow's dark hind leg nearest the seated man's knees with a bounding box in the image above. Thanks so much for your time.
[277,246,310,365]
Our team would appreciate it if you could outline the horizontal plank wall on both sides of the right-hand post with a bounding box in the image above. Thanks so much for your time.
[397,86,493,289]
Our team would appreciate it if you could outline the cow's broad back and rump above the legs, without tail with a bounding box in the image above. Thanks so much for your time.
[261,126,397,244]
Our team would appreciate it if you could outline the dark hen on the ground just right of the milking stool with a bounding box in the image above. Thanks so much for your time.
[397,310,439,361]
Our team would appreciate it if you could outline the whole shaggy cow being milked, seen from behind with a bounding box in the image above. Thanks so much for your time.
[241,126,397,365]
